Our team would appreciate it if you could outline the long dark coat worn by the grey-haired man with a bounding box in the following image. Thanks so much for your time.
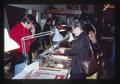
[64,32,90,74]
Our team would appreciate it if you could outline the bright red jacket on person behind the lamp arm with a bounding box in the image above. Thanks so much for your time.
[10,23,35,58]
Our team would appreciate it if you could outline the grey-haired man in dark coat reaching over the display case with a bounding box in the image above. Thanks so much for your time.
[59,21,90,79]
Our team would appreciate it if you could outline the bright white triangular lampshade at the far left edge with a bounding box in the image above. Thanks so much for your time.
[4,28,20,52]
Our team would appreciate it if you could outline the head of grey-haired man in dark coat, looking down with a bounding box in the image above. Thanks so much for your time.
[72,20,83,36]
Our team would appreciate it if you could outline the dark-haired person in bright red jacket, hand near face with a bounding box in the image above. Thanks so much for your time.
[10,14,36,75]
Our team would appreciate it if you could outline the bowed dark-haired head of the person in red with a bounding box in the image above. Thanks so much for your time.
[22,14,36,30]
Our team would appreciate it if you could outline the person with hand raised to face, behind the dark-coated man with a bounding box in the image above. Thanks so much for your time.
[84,24,103,78]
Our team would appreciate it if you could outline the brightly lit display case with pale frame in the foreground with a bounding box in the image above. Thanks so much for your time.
[13,47,72,79]
